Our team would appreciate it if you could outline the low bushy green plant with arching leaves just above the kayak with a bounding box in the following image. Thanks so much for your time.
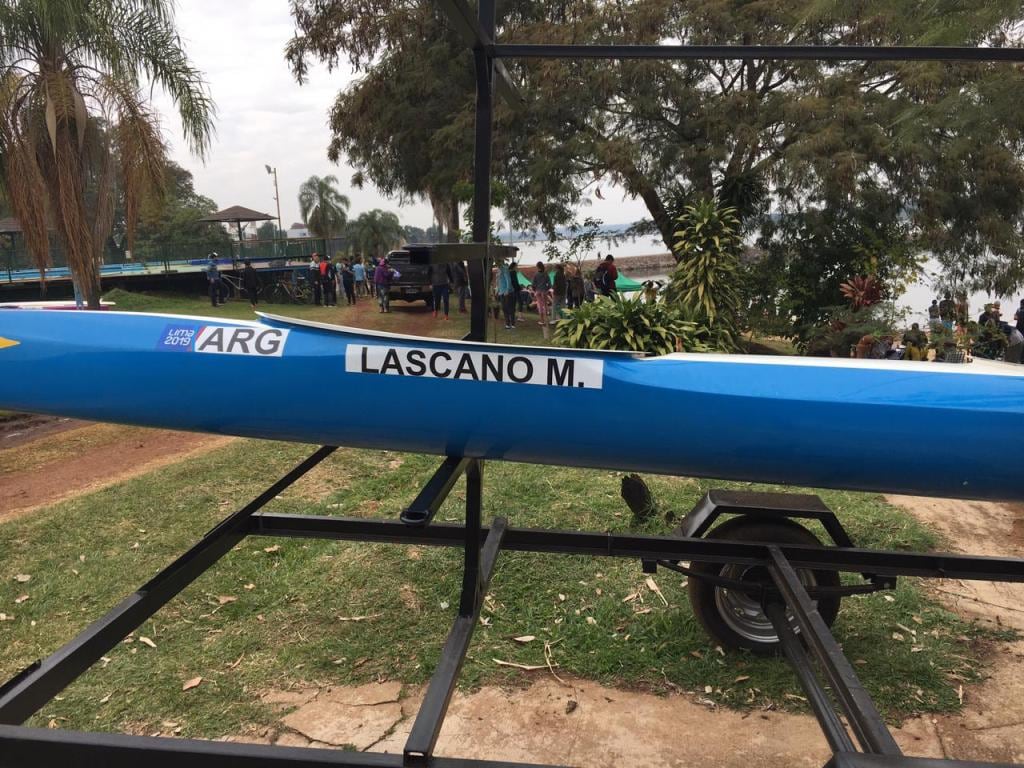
[554,294,709,354]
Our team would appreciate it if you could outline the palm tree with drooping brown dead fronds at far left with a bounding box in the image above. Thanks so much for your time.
[0,0,214,308]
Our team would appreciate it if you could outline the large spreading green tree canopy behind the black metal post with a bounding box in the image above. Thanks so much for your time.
[288,0,1024,296]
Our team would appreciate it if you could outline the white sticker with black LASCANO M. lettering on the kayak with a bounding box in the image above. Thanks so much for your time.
[345,344,604,389]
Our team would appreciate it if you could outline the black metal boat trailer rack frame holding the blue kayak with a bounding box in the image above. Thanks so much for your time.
[0,0,1024,768]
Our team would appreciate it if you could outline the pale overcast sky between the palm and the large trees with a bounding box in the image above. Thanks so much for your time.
[149,0,646,229]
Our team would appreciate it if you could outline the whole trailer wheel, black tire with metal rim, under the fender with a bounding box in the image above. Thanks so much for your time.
[688,517,840,655]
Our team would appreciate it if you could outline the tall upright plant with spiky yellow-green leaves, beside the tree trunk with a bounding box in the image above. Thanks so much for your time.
[666,199,742,352]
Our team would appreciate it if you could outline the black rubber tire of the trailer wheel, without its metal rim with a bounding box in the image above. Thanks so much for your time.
[687,516,841,655]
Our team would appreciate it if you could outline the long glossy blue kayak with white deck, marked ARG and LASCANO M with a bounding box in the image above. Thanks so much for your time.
[0,310,1024,500]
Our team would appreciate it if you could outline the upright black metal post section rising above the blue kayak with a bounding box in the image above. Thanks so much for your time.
[466,0,495,341]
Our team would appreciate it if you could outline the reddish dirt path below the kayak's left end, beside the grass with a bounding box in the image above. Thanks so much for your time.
[0,422,232,521]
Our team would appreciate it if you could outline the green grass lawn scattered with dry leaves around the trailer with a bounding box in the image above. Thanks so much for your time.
[0,286,1007,737]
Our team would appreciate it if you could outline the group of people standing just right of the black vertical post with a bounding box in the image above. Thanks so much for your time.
[495,253,618,331]
